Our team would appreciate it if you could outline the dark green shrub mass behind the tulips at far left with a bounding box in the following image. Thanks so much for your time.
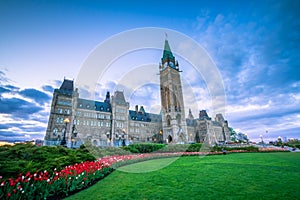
[0,143,95,178]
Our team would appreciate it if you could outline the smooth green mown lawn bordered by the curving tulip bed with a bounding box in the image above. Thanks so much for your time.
[65,153,300,200]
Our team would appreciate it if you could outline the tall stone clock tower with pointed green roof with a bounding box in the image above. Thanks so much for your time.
[159,39,187,143]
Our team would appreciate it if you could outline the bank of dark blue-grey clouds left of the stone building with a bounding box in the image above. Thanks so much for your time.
[0,71,53,141]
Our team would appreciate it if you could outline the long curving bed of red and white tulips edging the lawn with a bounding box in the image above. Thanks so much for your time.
[0,148,287,199]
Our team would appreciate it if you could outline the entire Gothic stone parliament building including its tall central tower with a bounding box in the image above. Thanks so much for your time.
[44,40,230,147]
